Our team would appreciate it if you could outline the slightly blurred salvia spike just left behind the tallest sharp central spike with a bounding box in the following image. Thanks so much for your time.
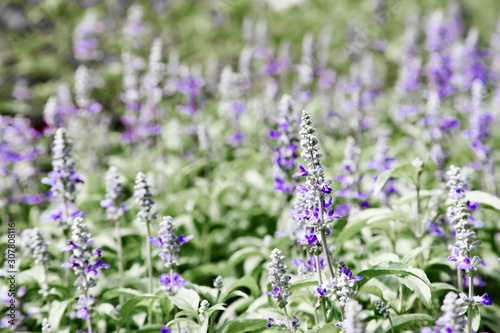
[269,94,299,194]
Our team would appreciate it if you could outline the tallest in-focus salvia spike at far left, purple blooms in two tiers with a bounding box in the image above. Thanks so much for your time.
[42,128,84,230]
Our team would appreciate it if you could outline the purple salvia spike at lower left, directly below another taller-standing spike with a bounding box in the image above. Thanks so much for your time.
[61,217,111,332]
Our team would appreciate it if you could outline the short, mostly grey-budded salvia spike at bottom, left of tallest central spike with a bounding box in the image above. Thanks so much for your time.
[266,249,301,332]
